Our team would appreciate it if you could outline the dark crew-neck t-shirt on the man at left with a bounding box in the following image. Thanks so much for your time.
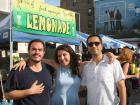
[5,64,52,105]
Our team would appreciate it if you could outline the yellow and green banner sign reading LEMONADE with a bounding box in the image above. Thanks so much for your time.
[13,0,76,38]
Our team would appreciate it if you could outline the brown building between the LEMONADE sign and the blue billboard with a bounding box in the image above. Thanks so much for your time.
[60,0,94,34]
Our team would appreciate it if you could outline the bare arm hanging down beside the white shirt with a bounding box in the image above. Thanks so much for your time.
[117,79,126,105]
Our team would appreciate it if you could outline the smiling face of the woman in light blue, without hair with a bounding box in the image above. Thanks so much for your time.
[57,50,70,67]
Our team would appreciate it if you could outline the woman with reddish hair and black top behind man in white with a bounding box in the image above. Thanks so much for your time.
[118,47,139,105]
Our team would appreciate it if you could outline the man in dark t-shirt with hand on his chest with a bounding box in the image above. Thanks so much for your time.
[5,39,52,105]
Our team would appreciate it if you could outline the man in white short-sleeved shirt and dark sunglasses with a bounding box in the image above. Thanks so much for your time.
[82,35,126,105]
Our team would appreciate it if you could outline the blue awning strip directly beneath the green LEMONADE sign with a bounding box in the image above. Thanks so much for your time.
[12,31,80,45]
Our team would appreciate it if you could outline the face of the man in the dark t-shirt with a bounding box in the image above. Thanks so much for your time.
[28,42,45,63]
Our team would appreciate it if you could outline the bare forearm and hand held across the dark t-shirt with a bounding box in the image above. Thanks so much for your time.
[5,81,44,100]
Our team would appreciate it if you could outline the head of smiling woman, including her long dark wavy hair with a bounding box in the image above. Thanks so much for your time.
[54,45,79,75]
